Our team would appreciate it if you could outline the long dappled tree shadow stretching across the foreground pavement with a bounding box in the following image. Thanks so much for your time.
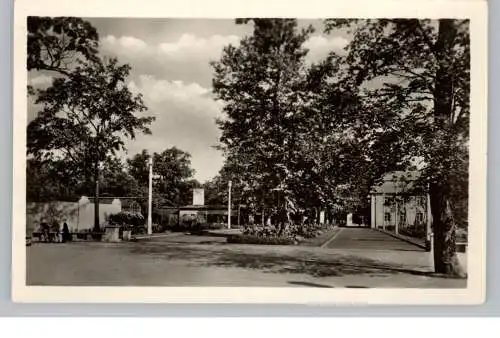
[130,245,462,278]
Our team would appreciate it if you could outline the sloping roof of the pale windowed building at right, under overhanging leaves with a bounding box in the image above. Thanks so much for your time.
[370,171,420,194]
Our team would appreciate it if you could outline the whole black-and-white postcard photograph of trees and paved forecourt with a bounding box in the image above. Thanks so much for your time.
[13,1,486,299]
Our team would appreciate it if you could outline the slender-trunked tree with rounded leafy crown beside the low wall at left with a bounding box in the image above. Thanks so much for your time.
[28,58,154,229]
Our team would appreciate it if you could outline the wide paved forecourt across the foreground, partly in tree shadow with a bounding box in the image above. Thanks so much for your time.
[26,229,467,288]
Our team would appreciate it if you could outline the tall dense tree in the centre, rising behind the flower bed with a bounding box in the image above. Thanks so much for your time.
[212,19,313,228]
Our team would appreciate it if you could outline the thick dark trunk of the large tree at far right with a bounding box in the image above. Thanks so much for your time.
[429,19,463,276]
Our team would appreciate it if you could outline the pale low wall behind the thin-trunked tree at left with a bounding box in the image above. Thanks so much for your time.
[26,197,122,234]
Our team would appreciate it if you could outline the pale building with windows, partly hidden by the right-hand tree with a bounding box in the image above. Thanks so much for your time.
[370,172,432,239]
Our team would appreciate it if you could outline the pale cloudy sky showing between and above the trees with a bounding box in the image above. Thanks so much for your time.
[28,18,348,183]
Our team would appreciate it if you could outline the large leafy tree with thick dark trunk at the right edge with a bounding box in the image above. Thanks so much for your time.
[323,19,470,275]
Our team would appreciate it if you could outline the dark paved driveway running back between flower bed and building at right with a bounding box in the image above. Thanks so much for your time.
[327,228,425,251]
